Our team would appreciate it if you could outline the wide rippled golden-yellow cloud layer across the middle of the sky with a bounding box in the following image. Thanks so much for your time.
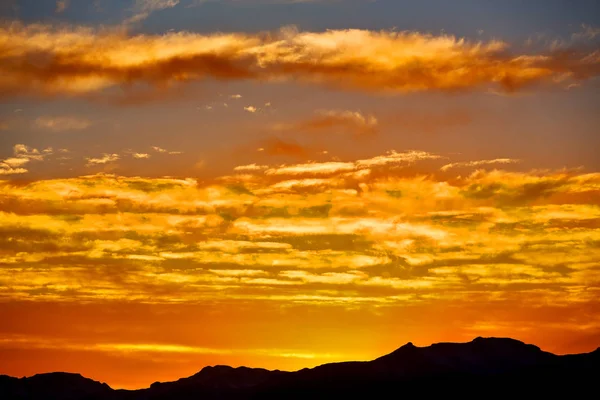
[0,150,600,305]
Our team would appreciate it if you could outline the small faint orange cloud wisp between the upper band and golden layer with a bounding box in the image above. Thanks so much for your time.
[274,110,379,135]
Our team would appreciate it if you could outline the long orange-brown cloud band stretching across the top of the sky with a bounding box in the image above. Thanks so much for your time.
[0,22,600,101]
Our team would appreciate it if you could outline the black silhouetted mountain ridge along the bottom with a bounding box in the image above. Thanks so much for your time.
[0,337,600,400]
